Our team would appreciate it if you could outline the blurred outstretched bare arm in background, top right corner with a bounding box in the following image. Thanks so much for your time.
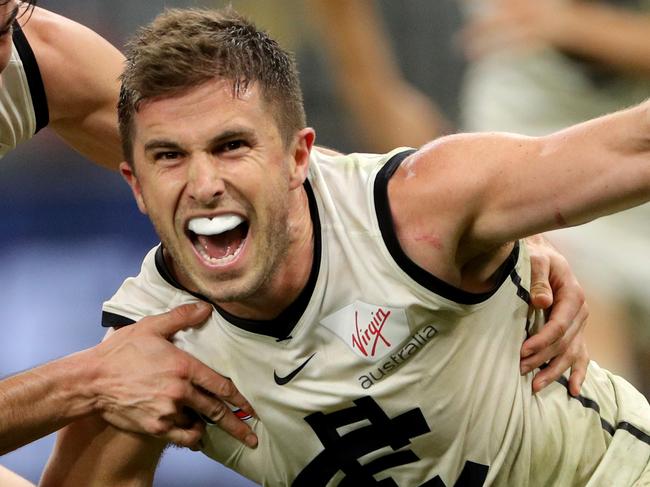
[464,0,650,76]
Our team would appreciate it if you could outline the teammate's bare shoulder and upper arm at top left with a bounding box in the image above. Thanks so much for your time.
[20,7,124,169]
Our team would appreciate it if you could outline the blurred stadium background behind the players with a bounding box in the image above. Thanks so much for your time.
[0,0,650,486]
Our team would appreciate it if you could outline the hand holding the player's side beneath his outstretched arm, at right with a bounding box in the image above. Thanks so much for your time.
[521,235,589,396]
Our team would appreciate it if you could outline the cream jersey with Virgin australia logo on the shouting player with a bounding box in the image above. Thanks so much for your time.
[104,150,650,487]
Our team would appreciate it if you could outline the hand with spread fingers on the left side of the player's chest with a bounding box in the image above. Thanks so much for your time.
[94,303,257,447]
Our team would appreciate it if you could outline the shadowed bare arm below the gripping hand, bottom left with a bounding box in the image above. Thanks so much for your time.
[39,416,165,487]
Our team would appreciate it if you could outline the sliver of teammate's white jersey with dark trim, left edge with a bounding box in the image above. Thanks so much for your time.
[0,23,49,157]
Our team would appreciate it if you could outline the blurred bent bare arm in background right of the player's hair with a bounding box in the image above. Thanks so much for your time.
[308,0,450,152]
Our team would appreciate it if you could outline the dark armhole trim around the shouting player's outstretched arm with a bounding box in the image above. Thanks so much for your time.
[374,150,519,304]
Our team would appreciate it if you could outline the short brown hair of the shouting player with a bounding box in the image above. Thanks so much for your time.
[118,8,306,165]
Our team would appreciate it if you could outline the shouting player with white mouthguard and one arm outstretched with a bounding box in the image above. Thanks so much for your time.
[43,10,650,486]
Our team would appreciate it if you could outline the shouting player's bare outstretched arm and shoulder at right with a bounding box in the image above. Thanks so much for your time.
[388,103,650,291]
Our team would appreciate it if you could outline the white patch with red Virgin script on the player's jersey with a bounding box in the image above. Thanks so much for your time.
[321,301,410,362]
